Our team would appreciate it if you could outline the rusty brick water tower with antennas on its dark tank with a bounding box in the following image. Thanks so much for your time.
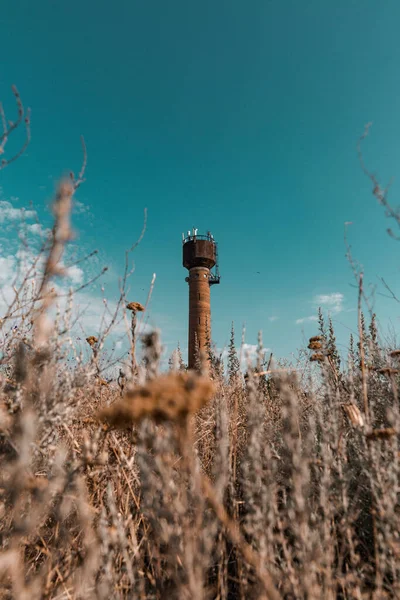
[182,229,220,369]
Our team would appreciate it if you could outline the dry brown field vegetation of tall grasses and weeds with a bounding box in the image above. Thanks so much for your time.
[0,86,400,600]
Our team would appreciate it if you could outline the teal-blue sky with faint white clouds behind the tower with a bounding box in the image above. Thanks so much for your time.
[0,0,400,364]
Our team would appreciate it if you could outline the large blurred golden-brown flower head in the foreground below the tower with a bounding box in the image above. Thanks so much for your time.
[98,372,215,428]
